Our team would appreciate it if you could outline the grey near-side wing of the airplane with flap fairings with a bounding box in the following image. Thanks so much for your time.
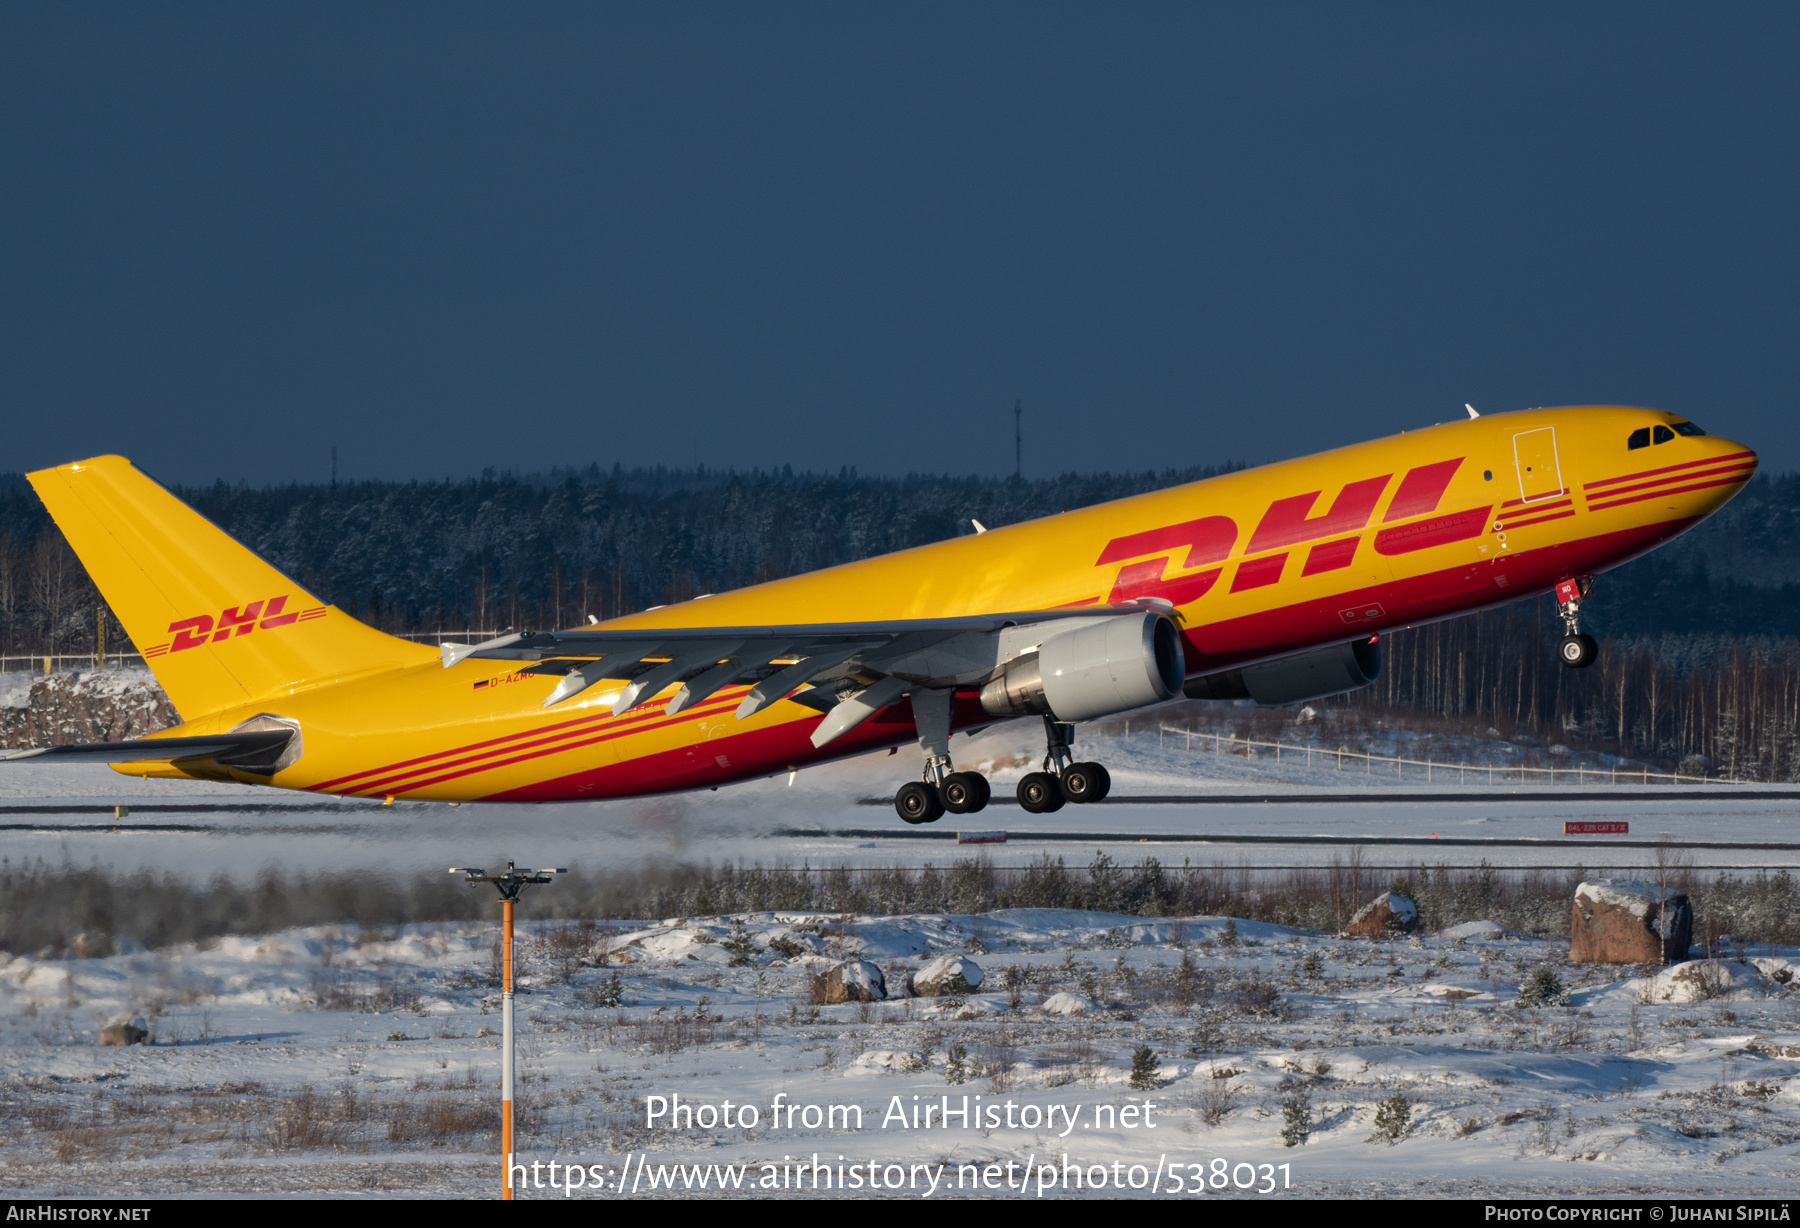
[439,605,1161,745]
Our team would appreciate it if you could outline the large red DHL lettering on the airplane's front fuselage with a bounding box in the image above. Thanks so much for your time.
[1094,457,1494,605]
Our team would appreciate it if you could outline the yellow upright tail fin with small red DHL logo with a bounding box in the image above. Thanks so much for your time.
[27,456,436,720]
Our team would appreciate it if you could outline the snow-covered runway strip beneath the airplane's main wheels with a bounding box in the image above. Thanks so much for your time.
[0,722,1800,877]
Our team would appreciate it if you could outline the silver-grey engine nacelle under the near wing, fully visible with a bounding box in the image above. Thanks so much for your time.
[981,610,1186,720]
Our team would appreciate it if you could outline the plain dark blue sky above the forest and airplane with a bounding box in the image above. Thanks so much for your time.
[0,4,1800,483]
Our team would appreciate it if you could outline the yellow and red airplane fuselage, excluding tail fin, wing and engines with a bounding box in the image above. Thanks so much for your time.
[87,407,1757,801]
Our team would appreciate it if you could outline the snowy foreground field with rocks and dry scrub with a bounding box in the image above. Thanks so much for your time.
[0,900,1800,1197]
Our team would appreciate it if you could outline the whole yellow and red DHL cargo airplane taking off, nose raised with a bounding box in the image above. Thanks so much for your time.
[7,405,1757,823]
